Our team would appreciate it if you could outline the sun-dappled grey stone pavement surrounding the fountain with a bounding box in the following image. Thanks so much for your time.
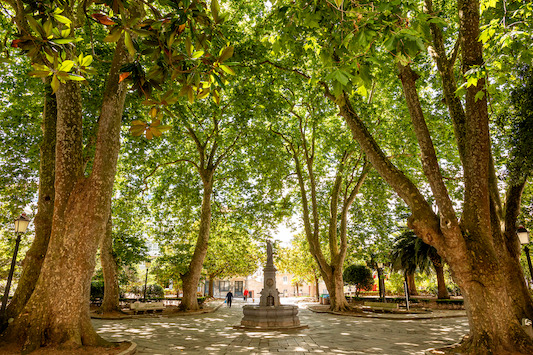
[93,300,468,355]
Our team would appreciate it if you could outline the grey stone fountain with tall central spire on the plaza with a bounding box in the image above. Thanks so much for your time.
[235,241,307,330]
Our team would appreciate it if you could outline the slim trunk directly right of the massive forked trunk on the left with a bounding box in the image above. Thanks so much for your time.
[100,217,120,313]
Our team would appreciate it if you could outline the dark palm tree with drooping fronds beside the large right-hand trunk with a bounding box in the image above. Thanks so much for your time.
[391,230,450,299]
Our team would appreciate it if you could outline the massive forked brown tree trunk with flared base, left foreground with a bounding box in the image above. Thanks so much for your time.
[2,40,128,352]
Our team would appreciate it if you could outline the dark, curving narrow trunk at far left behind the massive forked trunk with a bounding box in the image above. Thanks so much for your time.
[4,80,57,321]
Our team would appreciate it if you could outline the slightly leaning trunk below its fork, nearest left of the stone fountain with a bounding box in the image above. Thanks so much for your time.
[180,175,214,310]
